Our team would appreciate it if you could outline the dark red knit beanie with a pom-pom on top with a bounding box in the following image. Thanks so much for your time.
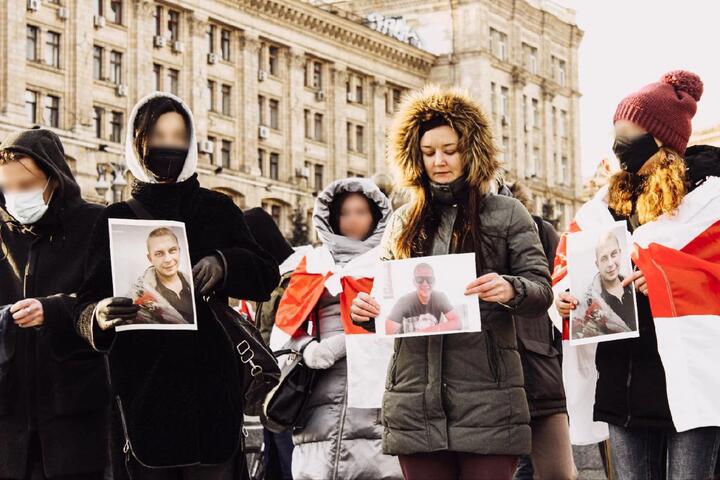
[613,70,703,155]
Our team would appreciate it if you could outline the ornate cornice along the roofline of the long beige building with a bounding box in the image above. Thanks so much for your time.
[238,0,436,76]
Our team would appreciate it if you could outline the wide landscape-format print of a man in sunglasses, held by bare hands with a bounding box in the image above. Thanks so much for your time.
[373,253,480,337]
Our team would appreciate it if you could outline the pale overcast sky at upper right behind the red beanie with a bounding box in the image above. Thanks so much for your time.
[555,0,720,177]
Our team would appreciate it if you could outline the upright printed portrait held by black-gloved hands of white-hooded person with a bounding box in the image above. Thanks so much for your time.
[108,219,197,332]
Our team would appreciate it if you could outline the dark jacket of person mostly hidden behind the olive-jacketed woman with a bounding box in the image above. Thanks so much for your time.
[515,215,567,418]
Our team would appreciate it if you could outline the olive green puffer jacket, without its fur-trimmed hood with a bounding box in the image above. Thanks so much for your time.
[382,194,552,455]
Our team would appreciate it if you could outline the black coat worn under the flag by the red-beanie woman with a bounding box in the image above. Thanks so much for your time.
[594,145,720,429]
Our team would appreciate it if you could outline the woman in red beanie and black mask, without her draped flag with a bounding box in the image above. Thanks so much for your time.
[555,70,720,478]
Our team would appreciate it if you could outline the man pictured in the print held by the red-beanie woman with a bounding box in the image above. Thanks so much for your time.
[573,232,637,338]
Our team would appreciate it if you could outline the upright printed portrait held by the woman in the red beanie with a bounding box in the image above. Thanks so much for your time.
[567,222,639,345]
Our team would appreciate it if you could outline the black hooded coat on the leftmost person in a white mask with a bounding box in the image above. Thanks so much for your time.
[0,130,109,479]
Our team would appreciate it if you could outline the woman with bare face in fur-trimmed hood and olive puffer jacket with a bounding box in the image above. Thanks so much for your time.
[352,86,552,479]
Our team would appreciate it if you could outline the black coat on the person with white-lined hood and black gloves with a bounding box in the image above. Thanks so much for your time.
[78,175,279,480]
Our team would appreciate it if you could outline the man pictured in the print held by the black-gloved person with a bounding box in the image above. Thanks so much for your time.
[130,227,195,324]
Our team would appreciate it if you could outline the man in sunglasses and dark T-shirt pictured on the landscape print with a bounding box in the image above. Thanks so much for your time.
[385,263,462,334]
